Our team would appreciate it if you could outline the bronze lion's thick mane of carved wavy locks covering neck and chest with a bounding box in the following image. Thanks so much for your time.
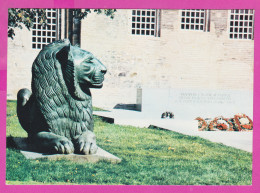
[32,40,93,139]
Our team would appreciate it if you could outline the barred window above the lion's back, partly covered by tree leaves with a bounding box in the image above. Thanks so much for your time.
[32,9,57,49]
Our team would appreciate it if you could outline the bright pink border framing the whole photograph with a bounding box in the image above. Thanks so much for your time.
[0,0,260,193]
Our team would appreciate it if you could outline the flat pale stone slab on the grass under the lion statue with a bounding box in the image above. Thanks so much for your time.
[13,138,121,163]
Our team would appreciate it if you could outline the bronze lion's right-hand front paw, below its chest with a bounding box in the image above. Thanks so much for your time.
[75,131,98,155]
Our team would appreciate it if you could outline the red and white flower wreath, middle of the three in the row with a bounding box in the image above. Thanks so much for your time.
[209,116,234,131]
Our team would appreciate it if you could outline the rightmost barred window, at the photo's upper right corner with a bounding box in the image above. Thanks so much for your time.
[229,9,254,40]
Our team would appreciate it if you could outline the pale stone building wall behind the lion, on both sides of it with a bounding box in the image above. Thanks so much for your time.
[8,9,254,111]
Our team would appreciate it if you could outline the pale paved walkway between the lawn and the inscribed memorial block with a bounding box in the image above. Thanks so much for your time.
[94,109,253,152]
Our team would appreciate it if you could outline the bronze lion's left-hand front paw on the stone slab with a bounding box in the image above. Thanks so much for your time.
[53,137,74,154]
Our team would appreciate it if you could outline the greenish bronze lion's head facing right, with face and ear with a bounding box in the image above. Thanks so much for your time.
[54,41,107,99]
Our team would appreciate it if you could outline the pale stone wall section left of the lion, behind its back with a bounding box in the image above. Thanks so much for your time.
[7,27,40,99]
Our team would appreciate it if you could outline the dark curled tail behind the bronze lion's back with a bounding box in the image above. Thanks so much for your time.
[17,88,32,132]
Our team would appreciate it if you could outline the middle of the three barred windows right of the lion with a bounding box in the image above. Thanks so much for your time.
[181,9,206,31]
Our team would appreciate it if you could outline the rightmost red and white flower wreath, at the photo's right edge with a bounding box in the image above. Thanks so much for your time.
[234,113,253,131]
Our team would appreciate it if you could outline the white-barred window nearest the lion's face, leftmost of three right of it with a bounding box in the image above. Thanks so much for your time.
[132,9,160,36]
